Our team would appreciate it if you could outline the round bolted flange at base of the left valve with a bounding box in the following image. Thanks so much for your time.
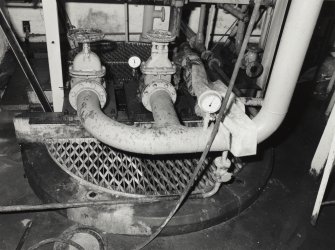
[69,80,107,110]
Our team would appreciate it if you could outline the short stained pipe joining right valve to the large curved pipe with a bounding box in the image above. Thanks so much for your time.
[150,90,180,127]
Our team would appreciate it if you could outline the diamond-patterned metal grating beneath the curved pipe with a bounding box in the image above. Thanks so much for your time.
[45,138,220,196]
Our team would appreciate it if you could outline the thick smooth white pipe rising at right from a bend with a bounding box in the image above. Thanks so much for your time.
[253,0,323,142]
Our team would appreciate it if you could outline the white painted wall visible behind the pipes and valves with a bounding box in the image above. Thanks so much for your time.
[4,2,259,42]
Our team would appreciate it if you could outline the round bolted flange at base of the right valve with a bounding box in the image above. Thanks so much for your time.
[142,80,177,111]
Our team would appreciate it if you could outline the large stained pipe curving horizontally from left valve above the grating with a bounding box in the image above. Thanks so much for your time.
[77,90,230,154]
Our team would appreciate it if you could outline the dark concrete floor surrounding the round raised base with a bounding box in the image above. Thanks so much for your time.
[0,83,335,250]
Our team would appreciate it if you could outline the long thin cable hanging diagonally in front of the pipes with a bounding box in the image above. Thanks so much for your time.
[135,0,261,250]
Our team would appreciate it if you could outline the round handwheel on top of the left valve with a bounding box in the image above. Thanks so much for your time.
[68,28,105,43]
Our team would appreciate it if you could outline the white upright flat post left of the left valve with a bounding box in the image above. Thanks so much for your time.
[42,0,64,112]
